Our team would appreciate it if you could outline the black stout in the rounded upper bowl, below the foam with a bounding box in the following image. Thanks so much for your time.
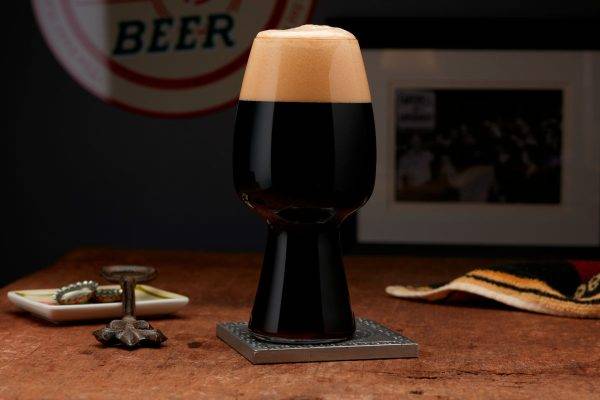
[233,101,375,223]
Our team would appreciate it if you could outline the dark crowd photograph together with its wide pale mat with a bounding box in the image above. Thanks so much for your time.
[330,21,600,247]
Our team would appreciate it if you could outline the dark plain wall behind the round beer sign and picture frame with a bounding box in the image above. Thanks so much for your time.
[5,0,600,284]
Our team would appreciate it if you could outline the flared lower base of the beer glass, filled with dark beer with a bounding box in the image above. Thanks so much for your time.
[249,225,355,343]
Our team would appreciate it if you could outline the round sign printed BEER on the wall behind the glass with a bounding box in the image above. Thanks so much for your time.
[32,0,314,117]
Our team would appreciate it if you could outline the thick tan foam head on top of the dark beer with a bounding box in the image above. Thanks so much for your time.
[240,25,371,103]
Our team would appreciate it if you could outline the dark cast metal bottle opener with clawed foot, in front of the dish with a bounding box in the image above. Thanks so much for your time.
[94,265,167,348]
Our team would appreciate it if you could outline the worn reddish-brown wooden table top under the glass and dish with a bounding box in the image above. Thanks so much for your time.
[0,250,600,399]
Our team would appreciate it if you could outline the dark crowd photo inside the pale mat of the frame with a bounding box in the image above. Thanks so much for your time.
[393,88,563,204]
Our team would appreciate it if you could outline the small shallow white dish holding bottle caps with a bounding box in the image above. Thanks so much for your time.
[8,285,189,323]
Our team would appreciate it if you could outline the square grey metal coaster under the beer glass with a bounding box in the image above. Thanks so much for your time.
[217,318,419,364]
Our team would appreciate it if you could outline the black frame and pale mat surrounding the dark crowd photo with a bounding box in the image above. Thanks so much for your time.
[330,19,600,249]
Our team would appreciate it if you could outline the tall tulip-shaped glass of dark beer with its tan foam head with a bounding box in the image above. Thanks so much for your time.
[233,25,376,343]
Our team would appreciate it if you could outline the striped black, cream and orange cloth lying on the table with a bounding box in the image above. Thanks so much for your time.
[386,261,600,318]
